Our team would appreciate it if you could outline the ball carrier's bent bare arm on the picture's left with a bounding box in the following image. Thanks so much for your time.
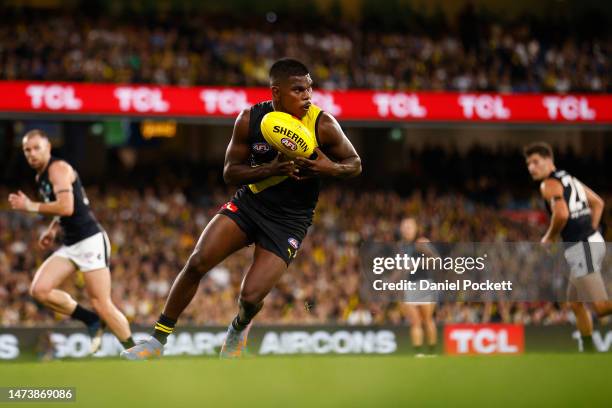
[223,109,296,185]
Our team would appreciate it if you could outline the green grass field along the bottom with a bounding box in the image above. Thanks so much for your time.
[0,353,612,408]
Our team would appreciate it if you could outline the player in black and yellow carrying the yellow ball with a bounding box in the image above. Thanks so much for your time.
[121,59,361,360]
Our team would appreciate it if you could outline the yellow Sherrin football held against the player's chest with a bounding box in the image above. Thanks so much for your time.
[260,111,317,158]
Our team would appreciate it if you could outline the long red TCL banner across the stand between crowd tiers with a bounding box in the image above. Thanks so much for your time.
[0,81,612,124]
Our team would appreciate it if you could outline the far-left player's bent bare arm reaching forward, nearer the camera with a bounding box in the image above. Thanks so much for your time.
[9,161,74,217]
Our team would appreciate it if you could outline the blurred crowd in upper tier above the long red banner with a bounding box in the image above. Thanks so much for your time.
[0,11,612,93]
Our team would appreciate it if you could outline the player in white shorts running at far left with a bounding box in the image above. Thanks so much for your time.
[9,130,134,353]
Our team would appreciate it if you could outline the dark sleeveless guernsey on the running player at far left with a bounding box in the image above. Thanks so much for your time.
[36,157,102,245]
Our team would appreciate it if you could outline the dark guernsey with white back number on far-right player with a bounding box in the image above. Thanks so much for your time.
[546,170,595,242]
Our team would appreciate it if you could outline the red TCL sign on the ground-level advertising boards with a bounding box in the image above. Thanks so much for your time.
[444,324,525,354]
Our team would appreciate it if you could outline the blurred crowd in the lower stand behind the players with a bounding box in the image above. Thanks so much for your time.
[0,187,612,326]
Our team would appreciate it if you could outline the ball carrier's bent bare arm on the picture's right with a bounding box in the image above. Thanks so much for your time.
[295,112,361,178]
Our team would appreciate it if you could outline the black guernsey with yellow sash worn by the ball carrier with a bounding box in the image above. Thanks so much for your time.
[236,101,320,223]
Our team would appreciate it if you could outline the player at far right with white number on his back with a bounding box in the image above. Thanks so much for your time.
[524,142,612,350]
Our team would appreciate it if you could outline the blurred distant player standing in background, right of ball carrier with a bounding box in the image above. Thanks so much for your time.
[399,217,438,357]
